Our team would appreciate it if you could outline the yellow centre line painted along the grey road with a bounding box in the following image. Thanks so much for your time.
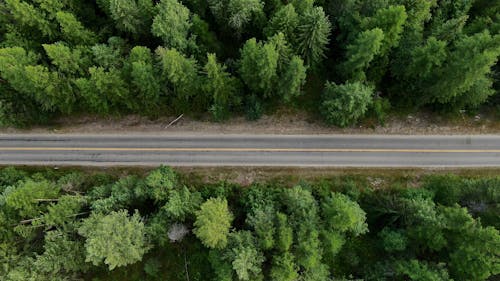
[0,147,500,153]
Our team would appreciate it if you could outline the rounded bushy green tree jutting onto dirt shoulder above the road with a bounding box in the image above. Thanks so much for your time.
[321,82,373,127]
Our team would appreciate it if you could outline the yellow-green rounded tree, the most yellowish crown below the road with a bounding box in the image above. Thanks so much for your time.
[193,198,233,249]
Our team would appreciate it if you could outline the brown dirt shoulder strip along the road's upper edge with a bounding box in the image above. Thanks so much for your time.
[0,112,500,135]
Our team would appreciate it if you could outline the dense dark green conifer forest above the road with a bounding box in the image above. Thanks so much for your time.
[0,0,500,127]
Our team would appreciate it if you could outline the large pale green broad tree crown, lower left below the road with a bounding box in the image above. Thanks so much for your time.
[78,210,148,270]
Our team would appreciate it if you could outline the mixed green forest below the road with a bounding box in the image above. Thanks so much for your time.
[0,166,500,281]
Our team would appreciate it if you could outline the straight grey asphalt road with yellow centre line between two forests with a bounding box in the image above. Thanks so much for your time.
[0,134,500,167]
